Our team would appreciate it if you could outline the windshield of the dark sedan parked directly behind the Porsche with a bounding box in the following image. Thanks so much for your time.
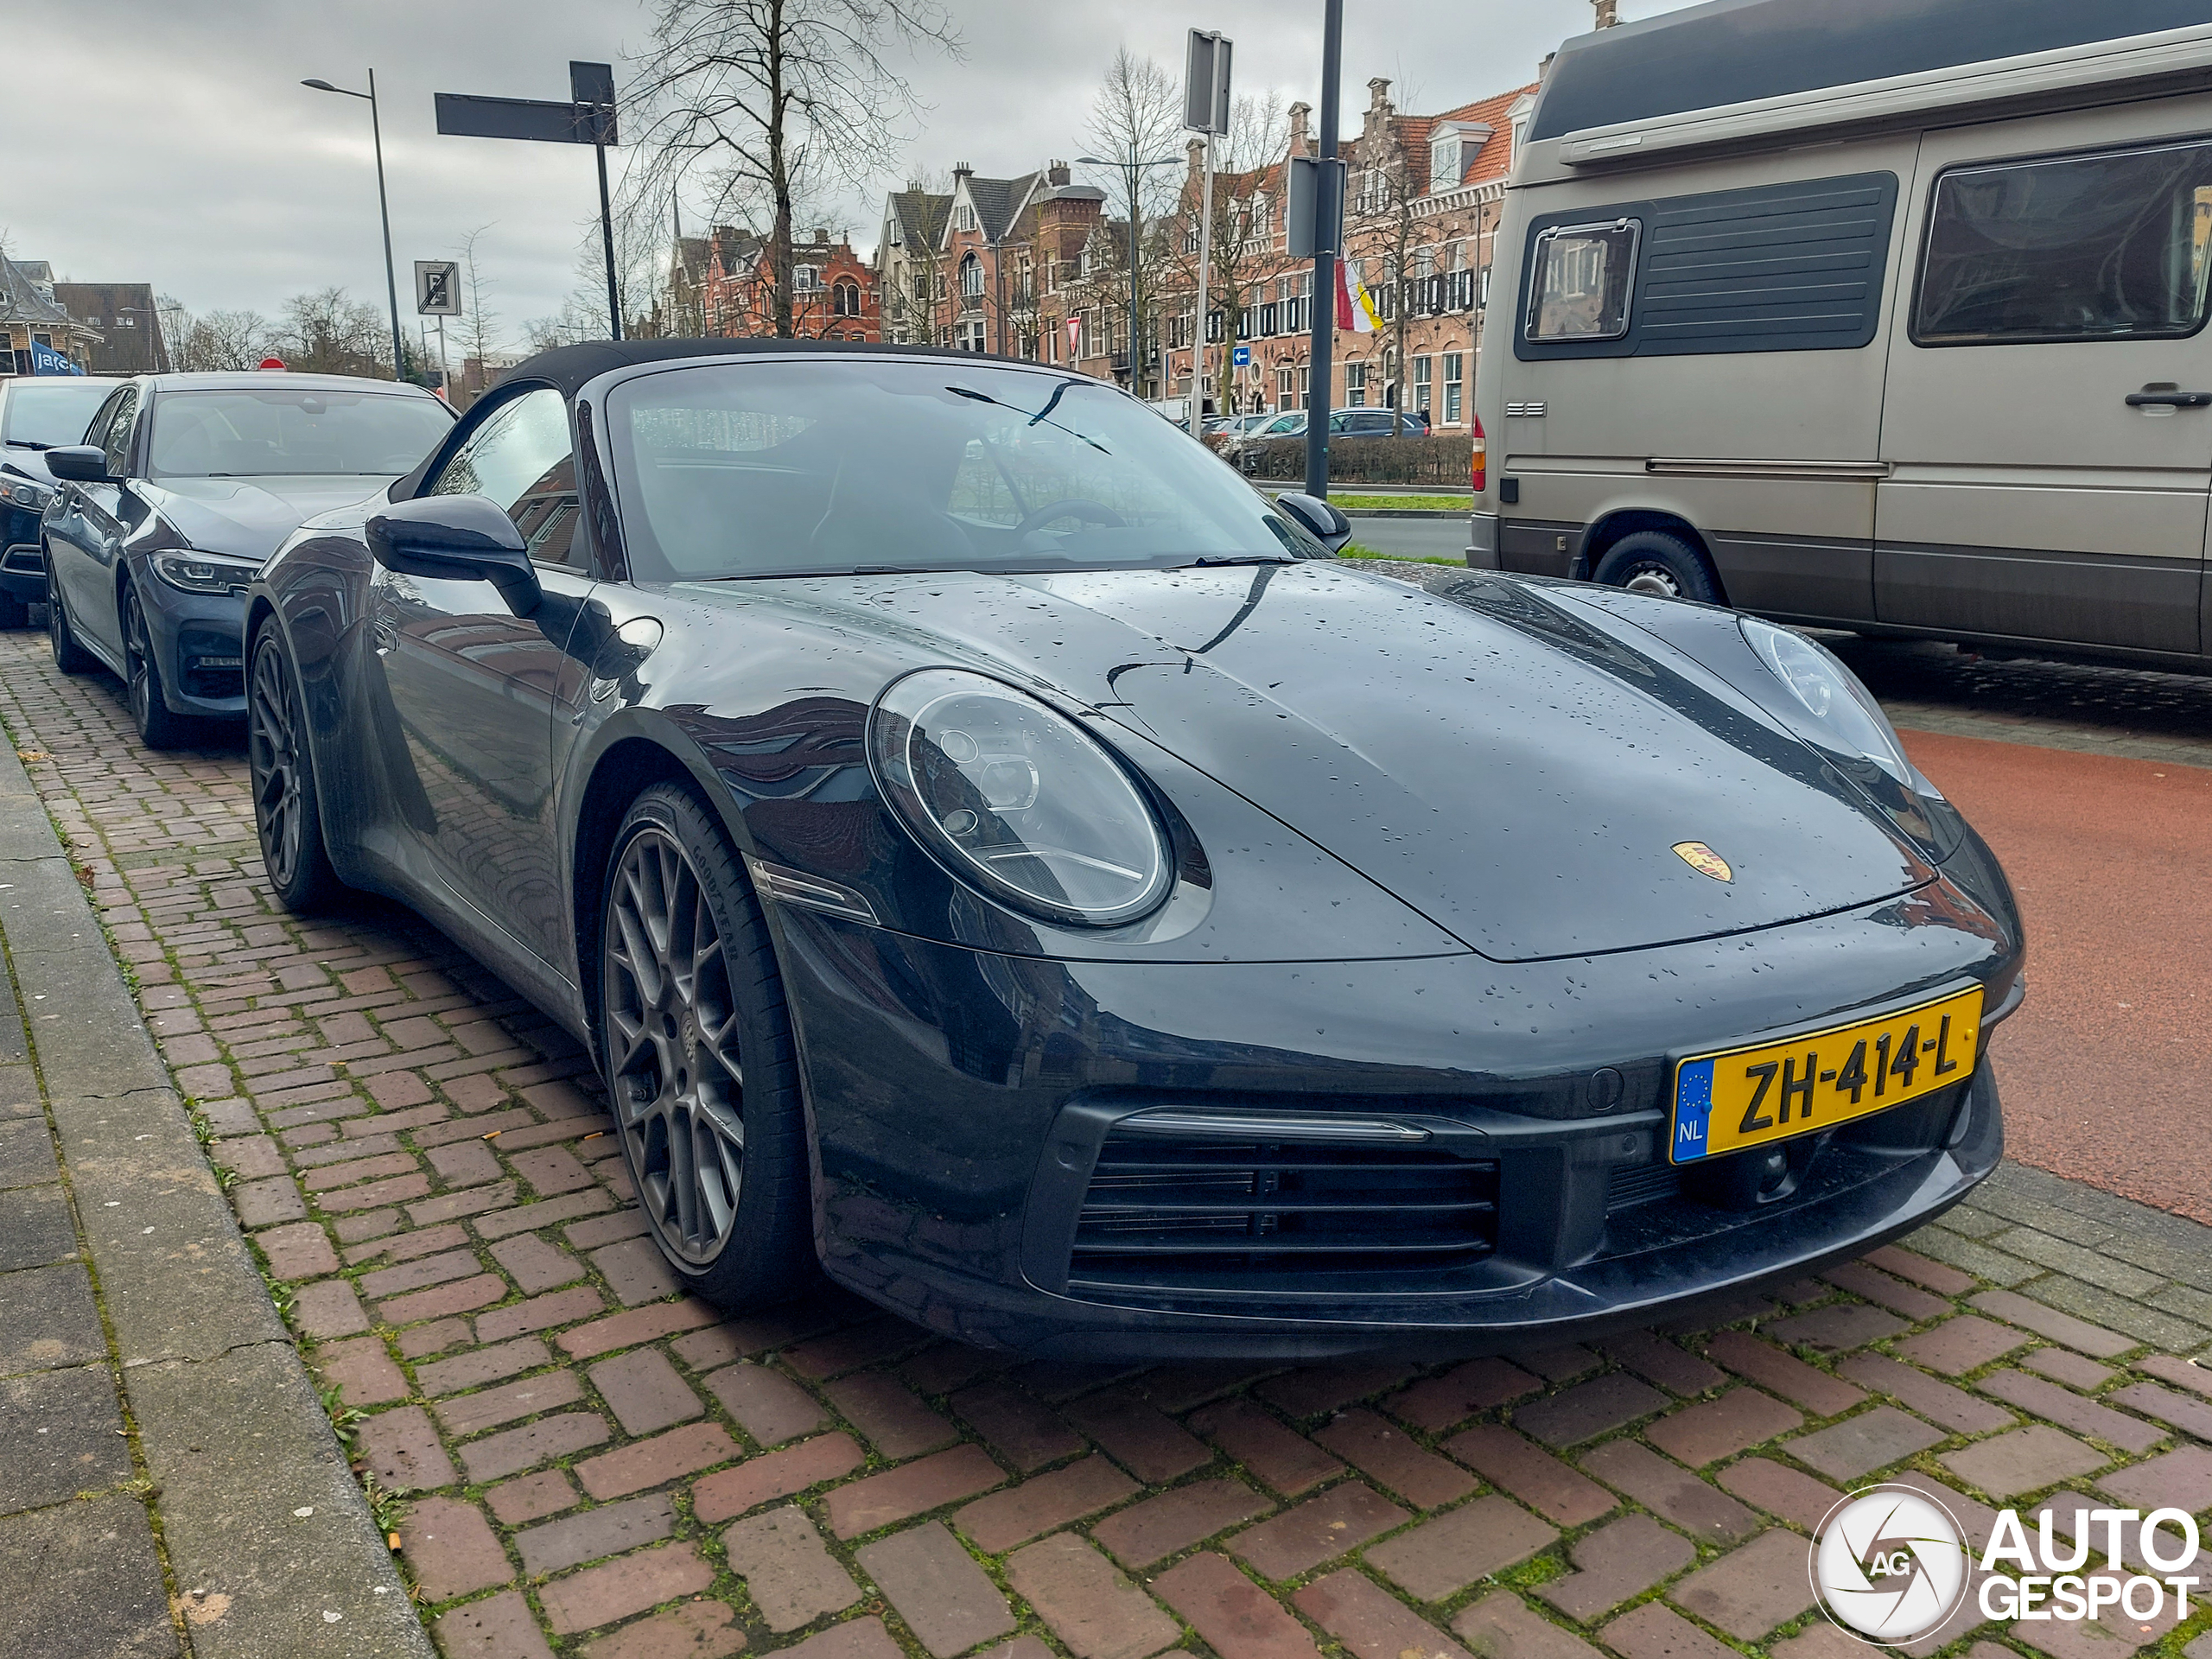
[149,387,454,478]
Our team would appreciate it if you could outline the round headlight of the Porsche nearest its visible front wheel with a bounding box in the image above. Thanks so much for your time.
[868,668,1174,927]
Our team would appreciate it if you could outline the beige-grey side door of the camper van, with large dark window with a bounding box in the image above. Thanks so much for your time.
[1873,98,2212,655]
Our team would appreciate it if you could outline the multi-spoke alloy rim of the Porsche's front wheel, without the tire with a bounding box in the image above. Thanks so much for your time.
[601,825,746,1269]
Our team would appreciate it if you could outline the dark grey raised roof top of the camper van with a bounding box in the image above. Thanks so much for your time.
[1529,0,2212,139]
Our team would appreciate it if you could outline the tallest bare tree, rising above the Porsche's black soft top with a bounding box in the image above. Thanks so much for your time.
[626,0,960,339]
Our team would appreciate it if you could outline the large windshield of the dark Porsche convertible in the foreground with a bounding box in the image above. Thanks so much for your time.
[608,359,1327,582]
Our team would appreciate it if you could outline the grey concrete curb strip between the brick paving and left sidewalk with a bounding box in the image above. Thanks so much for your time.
[0,743,434,1659]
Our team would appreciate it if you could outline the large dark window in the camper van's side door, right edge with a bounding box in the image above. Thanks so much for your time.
[1913,143,2212,345]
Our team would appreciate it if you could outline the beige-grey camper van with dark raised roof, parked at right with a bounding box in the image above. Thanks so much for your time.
[1469,0,2212,668]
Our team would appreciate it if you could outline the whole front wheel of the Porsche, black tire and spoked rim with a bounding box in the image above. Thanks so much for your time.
[597,783,817,1314]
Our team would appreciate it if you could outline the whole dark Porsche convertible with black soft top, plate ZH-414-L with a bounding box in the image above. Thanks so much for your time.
[248,340,2022,1356]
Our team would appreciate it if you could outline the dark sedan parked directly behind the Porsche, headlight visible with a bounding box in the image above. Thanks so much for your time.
[40,374,454,747]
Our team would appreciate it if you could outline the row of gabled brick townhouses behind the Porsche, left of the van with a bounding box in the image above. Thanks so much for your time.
[876,79,1537,429]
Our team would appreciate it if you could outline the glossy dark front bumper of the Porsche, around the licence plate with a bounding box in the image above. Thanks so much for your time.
[777,882,2019,1358]
